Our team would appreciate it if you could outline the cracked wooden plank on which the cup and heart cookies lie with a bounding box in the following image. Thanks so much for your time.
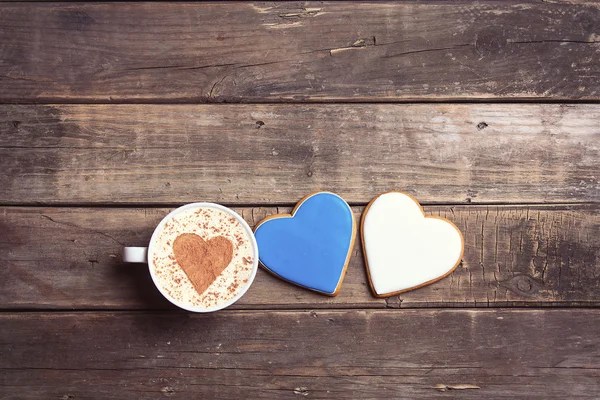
[0,205,600,309]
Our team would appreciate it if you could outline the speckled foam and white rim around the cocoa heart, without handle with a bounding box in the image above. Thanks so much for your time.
[148,203,258,312]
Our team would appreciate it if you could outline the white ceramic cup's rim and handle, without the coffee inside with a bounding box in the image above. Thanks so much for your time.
[123,203,258,312]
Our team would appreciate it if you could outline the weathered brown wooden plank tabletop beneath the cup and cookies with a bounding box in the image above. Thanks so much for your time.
[0,0,600,400]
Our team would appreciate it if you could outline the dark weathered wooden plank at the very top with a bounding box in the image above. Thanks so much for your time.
[0,0,600,102]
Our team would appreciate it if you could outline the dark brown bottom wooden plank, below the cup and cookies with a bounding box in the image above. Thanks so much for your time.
[0,310,600,400]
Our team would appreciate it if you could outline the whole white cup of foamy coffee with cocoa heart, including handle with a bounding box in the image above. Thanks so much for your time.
[124,203,258,312]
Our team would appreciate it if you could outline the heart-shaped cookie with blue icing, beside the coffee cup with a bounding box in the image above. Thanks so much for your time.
[254,192,354,294]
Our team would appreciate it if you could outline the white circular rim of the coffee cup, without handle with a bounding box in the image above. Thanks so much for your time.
[148,202,258,313]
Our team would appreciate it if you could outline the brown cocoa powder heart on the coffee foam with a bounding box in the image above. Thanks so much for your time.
[173,233,233,294]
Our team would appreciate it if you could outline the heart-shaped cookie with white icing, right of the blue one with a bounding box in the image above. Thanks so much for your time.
[361,192,464,297]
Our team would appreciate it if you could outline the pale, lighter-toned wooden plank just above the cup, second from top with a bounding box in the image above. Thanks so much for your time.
[0,104,600,205]
